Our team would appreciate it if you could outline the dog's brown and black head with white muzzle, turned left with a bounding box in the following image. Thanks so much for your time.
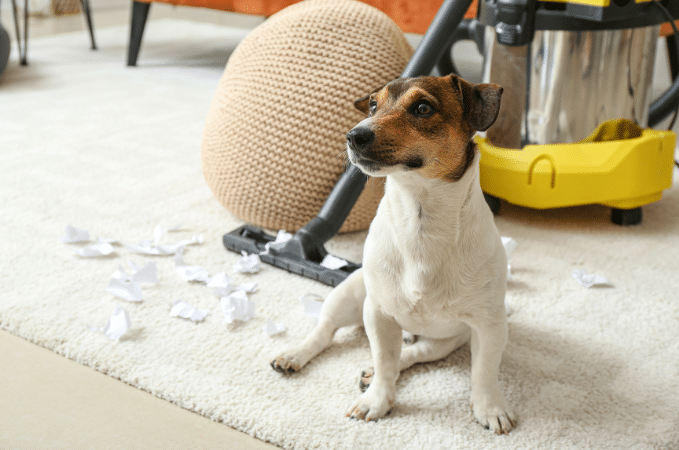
[347,75,502,181]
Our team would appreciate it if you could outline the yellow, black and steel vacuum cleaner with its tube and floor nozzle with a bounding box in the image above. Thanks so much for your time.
[223,0,679,286]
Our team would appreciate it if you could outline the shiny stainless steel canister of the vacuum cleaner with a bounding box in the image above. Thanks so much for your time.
[483,26,660,148]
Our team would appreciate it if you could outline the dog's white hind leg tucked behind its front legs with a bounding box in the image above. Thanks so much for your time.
[358,324,471,392]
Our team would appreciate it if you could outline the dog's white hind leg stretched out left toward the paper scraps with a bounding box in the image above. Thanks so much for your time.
[271,269,366,374]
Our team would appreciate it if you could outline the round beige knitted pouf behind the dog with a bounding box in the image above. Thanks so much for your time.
[201,0,412,232]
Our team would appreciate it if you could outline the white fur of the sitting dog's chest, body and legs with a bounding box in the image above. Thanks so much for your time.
[272,81,515,433]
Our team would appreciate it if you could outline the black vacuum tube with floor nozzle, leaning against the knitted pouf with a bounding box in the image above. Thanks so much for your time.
[224,0,472,286]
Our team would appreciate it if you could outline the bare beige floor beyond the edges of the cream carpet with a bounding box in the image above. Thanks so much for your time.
[0,4,277,450]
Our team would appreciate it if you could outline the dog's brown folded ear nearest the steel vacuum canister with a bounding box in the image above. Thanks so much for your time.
[450,74,503,131]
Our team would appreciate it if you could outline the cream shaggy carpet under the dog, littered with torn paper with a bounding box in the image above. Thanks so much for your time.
[0,20,679,449]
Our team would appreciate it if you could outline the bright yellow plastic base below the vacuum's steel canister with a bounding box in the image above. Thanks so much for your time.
[476,129,675,214]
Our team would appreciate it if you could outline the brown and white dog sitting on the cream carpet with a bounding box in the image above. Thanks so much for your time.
[271,75,516,434]
